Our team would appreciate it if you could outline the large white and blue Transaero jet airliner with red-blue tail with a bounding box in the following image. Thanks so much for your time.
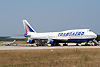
[23,20,97,46]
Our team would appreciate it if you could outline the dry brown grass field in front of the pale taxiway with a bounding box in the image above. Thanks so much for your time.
[0,49,100,67]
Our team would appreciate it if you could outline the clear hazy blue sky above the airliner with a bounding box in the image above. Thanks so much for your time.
[0,0,100,36]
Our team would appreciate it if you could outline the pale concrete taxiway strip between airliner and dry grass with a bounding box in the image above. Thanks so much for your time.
[0,46,100,50]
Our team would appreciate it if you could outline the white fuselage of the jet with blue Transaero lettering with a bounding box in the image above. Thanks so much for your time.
[27,29,97,41]
